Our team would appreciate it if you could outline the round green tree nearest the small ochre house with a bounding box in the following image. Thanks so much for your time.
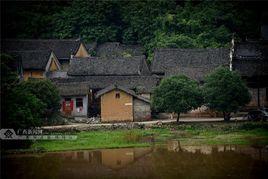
[152,75,203,122]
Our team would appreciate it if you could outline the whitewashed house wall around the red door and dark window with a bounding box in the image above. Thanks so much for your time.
[60,95,88,117]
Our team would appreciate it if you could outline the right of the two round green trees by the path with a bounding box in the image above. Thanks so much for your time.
[203,67,251,121]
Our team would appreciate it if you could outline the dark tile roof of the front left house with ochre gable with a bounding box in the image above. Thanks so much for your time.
[12,50,51,70]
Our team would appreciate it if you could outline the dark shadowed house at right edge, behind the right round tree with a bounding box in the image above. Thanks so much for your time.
[232,40,268,108]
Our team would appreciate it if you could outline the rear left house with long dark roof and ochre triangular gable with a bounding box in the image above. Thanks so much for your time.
[1,39,95,79]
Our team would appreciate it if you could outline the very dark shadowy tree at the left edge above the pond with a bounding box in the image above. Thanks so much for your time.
[0,54,46,129]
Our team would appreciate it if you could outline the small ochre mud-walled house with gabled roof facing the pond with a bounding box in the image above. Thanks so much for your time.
[96,85,151,122]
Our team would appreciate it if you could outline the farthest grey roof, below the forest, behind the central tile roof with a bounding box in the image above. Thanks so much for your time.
[96,42,145,57]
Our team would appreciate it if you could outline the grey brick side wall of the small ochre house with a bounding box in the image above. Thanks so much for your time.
[133,98,151,121]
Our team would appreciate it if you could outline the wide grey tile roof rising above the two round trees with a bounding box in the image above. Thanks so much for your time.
[151,48,230,80]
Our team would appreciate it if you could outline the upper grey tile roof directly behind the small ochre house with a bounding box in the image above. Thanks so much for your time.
[68,56,150,76]
